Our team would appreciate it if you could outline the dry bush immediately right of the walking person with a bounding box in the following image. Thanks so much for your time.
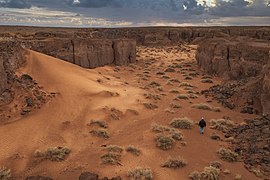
[210,119,235,133]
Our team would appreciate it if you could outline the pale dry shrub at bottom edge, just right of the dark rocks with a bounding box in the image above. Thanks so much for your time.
[127,167,153,180]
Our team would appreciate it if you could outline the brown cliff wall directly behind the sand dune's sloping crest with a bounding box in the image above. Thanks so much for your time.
[23,39,136,68]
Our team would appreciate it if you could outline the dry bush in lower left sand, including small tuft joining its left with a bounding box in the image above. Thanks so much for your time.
[34,147,71,161]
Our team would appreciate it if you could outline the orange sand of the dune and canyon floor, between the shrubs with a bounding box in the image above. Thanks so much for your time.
[0,47,256,179]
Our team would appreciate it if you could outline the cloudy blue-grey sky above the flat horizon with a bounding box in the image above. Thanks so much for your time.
[0,0,270,27]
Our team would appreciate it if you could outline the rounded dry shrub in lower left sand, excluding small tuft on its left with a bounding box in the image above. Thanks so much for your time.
[44,147,71,161]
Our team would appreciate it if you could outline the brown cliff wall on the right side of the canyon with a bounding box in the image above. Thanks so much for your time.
[196,40,270,113]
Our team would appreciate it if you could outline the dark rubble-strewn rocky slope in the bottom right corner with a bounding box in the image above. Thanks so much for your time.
[225,115,270,176]
